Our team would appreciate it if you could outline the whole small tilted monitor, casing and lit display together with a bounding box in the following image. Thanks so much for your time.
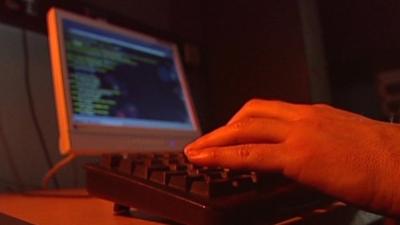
[48,8,200,154]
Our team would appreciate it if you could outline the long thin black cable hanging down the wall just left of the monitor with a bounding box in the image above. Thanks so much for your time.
[22,29,60,188]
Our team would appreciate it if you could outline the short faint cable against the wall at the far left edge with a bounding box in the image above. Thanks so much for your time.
[0,111,25,191]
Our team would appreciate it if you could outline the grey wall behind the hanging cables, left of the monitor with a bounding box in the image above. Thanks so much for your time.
[0,24,94,190]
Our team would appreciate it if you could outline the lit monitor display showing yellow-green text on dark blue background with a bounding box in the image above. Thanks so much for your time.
[63,20,192,128]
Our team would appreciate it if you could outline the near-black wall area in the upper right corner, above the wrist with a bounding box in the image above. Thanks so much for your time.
[318,0,400,120]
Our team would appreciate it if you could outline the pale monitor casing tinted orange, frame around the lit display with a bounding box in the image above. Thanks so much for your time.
[47,8,201,155]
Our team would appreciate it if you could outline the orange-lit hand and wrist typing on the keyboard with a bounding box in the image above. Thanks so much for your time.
[185,100,400,216]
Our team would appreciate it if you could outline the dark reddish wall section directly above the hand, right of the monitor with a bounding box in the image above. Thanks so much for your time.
[203,0,311,125]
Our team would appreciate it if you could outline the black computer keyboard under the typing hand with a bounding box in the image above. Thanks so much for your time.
[86,153,331,225]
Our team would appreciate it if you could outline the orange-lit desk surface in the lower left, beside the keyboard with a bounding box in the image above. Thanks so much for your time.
[0,190,161,225]
